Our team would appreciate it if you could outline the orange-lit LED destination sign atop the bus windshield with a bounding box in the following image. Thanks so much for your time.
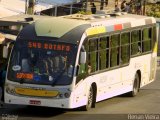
[28,42,71,52]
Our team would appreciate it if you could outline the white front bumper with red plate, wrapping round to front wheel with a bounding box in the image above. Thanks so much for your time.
[4,92,87,109]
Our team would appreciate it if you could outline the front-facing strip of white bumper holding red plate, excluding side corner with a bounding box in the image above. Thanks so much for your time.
[5,93,74,108]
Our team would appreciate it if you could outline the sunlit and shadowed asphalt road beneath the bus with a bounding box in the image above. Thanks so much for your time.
[0,69,160,120]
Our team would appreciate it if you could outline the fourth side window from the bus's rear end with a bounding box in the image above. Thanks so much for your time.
[110,34,120,67]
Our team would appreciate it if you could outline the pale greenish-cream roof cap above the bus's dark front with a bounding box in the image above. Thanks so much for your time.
[35,17,88,38]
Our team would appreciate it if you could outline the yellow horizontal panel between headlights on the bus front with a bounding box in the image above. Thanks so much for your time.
[15,88,58,97]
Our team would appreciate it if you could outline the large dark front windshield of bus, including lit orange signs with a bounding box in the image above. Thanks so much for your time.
[8,40,77,85]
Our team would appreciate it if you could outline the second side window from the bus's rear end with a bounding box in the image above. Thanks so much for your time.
[131,30,142,55]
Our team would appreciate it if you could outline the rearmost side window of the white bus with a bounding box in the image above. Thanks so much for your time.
[142,28,152,52]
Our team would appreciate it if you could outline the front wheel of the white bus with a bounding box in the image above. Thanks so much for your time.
[82,86,95,111]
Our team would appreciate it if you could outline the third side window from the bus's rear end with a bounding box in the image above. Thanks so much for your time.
[121,32,130,64]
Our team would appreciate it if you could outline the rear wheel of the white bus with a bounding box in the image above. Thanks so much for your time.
[129,74,140,97]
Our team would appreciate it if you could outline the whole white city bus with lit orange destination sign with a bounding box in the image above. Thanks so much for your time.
[5,14,158,109]
